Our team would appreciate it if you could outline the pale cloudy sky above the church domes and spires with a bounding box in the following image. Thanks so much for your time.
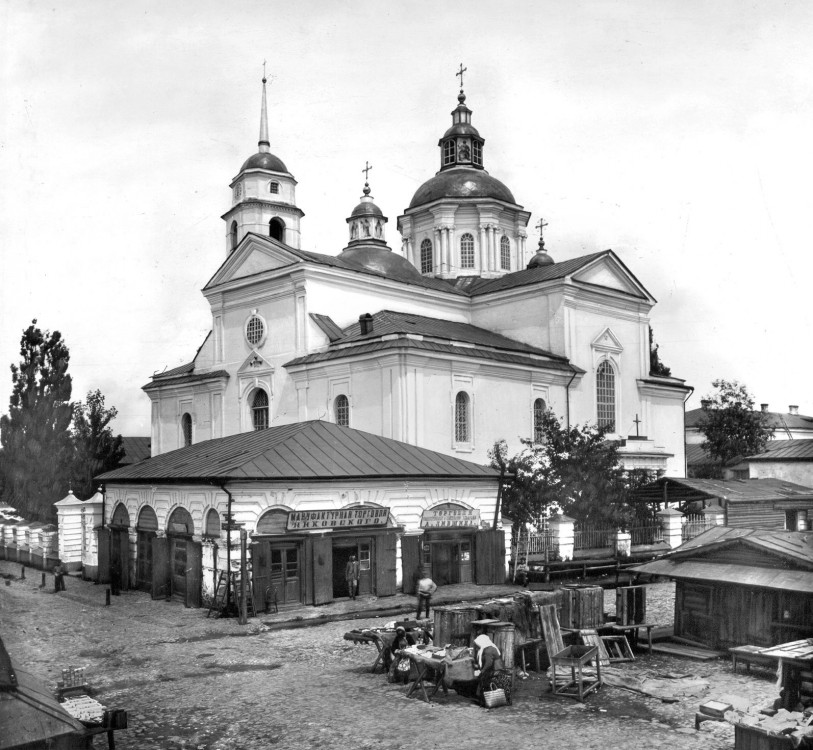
[0,0,813,435]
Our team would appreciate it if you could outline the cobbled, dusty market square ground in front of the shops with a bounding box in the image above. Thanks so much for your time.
[0,562,776,750]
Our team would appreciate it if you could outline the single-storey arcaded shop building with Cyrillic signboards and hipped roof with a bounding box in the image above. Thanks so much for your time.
[97,421,510,608]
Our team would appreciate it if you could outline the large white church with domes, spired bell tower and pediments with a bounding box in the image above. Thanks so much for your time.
[144,76,690,476]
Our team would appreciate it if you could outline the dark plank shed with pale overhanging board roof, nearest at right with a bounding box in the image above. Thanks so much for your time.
[632,526,813,649]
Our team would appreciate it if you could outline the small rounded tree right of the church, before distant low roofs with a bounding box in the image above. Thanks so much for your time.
[698,379,773,468]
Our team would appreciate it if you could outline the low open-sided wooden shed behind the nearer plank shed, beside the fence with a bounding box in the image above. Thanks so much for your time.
[635,477,813,531]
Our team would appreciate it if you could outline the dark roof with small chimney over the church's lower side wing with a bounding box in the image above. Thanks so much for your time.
[285,310,583,372]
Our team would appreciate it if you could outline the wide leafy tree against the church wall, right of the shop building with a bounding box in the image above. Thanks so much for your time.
[489,411,633,526]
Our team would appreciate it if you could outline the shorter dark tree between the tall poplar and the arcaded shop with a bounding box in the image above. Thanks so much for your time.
[71,389,124,500]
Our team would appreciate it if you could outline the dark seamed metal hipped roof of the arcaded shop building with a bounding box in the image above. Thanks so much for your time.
[96,421,499,483]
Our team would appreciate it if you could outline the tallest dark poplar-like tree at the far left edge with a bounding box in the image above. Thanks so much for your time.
[0,319,73,522]
